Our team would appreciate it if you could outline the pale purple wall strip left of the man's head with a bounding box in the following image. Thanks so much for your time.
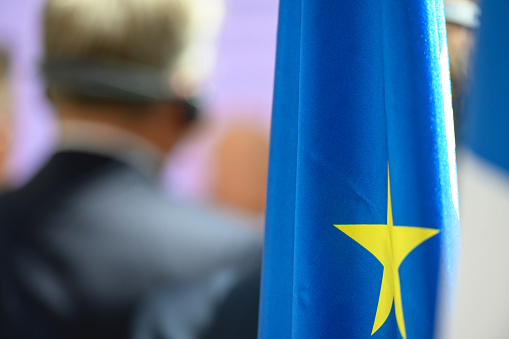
[0,0,54,186]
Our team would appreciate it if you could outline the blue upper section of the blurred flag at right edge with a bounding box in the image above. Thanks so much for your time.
[464,0,509,172]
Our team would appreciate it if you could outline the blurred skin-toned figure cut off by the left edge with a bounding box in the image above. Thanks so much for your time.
[0,49,11,190]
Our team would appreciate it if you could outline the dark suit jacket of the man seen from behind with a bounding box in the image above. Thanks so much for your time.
[0,152,261,339]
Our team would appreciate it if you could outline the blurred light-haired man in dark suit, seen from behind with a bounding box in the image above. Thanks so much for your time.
[0,0,261,339]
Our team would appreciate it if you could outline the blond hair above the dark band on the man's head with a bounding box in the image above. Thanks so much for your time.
[44,0,189,69]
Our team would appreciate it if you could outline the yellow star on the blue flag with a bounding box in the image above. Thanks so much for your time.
[334,174,439,339]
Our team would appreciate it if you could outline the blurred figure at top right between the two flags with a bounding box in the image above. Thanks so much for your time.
[444,0,480,139]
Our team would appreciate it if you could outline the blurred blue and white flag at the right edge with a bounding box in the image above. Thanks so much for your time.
[450,0,509,339]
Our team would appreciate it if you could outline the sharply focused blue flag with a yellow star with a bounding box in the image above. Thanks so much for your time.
[259,0,459,339]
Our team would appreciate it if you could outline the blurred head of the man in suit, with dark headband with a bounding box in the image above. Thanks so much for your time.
[43,0,198,151]
